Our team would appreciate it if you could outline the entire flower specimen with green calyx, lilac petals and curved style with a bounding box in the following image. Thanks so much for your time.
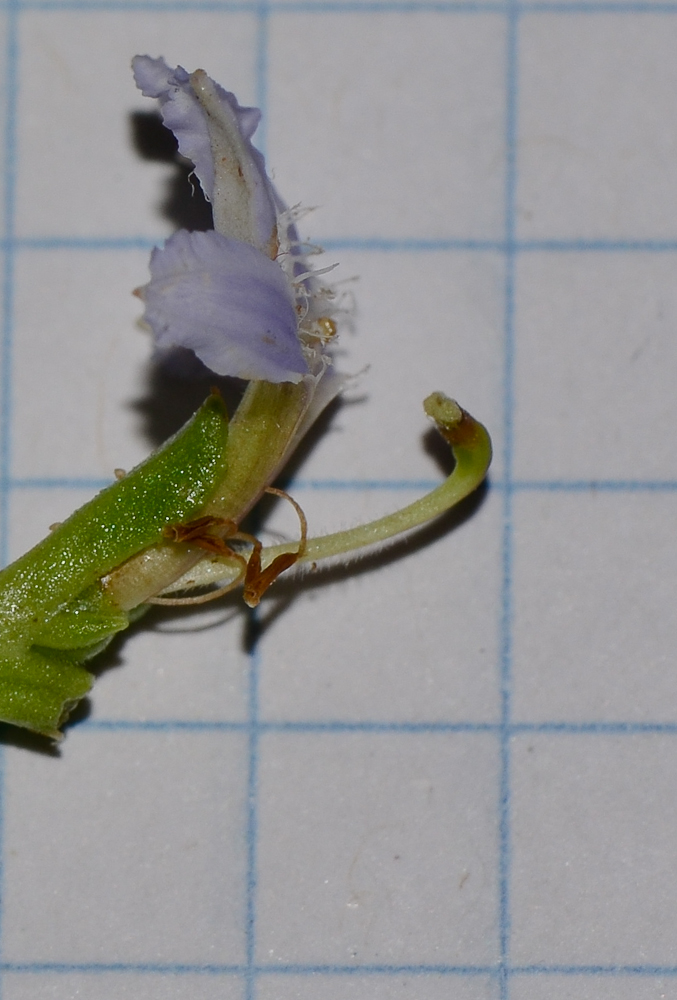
[0,56,491,738]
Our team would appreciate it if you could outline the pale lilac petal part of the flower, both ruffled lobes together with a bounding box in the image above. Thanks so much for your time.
[133,56,338,386]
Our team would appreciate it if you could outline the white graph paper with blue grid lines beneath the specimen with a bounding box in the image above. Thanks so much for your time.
[0,0,677,1000]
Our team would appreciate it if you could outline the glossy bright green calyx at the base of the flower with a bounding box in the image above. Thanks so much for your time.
[0,396,228,738]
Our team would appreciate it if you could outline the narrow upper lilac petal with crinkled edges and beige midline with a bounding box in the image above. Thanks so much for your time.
[132,56,277,256]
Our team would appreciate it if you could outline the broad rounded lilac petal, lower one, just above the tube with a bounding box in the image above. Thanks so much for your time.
[143,229,308,382]
